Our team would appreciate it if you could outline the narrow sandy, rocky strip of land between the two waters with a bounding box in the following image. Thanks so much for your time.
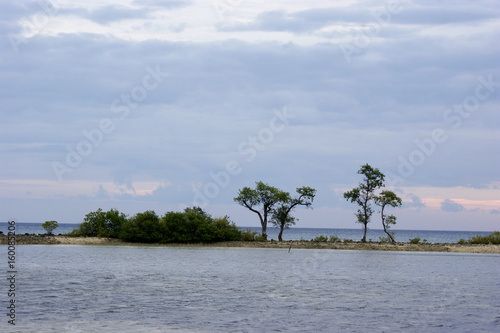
[0,235,500,253]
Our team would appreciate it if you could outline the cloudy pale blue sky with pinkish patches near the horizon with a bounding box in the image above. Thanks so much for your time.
[0,0,500,231]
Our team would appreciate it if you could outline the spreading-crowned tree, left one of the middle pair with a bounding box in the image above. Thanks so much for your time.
[234,182,290,240]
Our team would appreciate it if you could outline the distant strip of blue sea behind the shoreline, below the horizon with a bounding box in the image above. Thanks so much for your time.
[0,222,493,243]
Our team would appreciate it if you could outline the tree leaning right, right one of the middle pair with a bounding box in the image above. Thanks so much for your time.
[270,186,316,242]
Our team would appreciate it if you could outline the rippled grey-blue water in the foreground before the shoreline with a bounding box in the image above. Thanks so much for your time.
[0,245,500,332]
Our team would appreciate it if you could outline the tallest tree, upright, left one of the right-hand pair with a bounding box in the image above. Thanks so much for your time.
[344,163,385,243]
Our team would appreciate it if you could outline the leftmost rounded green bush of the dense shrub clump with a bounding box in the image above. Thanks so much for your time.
[68,208,127,238]
